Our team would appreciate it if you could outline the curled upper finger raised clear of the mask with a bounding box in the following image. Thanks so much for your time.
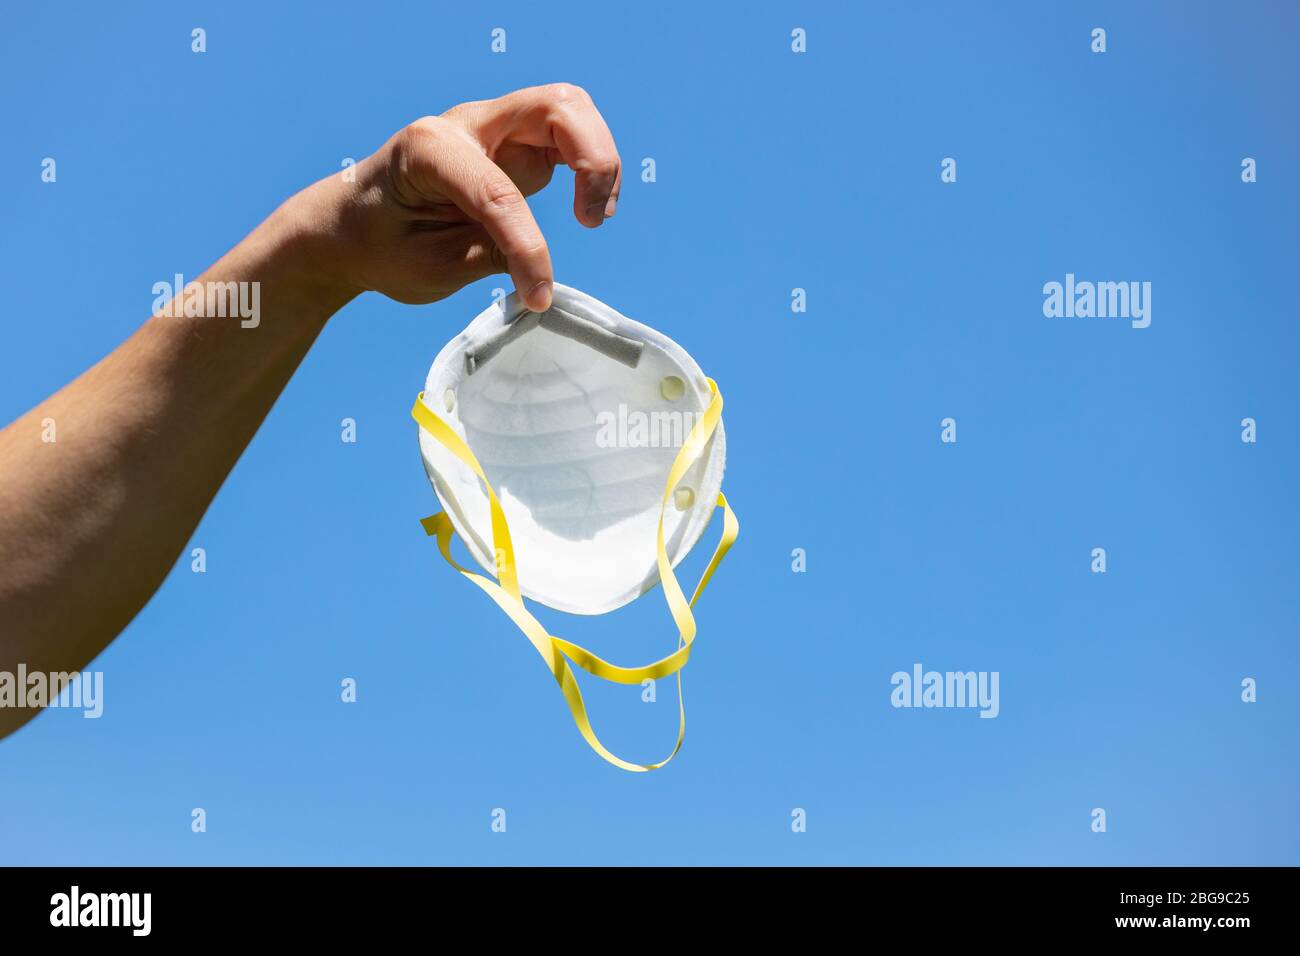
[477,83,623,228]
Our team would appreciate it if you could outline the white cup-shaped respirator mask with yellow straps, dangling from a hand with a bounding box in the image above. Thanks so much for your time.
[411,285,740,770]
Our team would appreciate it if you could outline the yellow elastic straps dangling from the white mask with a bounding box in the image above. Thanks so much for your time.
[411,378,740,771]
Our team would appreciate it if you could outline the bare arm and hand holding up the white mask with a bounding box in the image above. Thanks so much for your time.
[0,83,621,736]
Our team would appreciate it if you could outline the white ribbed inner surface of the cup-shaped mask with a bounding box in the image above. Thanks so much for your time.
[456,323,709,609]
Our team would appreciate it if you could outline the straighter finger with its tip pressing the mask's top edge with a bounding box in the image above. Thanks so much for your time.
[403,118,555,312]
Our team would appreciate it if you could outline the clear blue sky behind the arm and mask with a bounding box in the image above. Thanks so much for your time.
[0,3,1300,864]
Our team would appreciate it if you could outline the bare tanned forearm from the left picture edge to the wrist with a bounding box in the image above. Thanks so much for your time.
[0,174,355,736]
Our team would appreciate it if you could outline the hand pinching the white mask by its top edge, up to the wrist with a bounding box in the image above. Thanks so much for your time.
[332,83,621,312]
